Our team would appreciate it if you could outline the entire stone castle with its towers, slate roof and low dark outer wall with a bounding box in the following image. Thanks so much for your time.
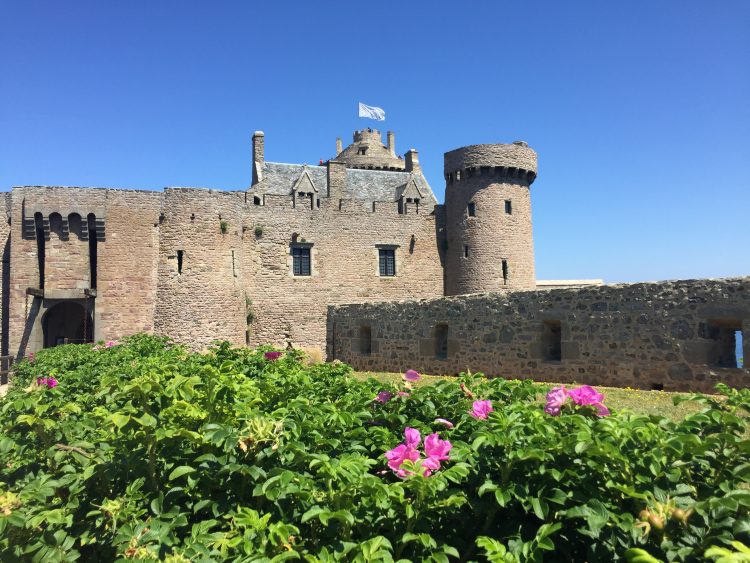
[0,129,750,388]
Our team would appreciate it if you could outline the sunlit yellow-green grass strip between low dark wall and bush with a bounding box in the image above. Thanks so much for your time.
[352,371,702,421]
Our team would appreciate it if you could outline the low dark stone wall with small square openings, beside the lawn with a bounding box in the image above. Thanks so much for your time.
[328,278,750,391]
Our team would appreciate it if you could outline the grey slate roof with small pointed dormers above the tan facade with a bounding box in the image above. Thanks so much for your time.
[251,162,437,204]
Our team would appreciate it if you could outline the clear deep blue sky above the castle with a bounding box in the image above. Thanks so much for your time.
[0,0,750,282]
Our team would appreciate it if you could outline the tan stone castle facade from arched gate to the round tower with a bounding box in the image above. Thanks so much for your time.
[0,187,443,355]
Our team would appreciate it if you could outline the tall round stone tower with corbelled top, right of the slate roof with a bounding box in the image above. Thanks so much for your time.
[444,141,536,295]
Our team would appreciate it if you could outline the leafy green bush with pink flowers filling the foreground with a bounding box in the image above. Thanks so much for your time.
[0,336,750,562]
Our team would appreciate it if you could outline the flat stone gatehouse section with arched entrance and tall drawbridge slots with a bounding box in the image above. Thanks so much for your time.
[3,187,162,355]
